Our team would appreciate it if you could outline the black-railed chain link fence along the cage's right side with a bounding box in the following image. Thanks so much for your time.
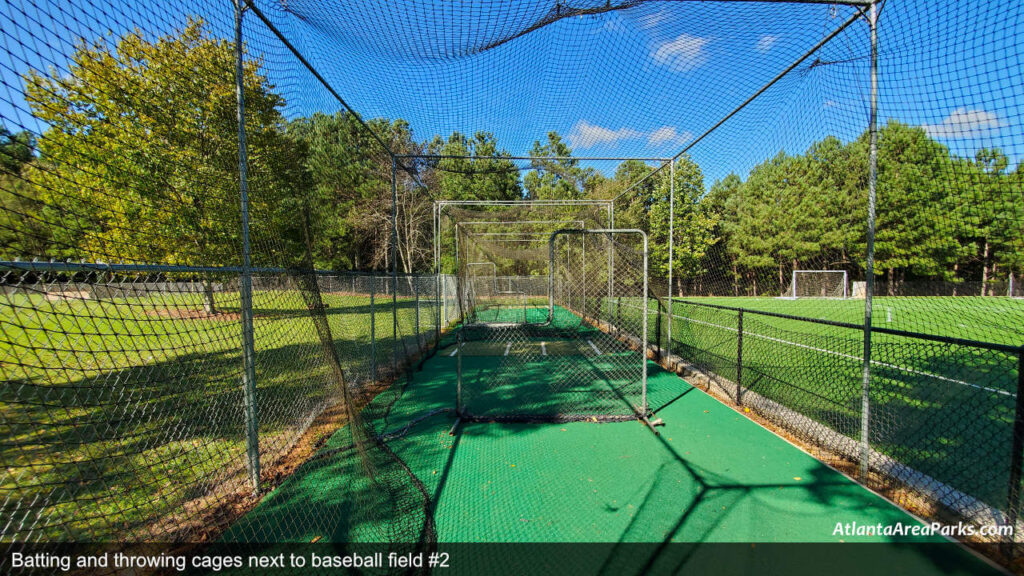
[647,299,1024,544]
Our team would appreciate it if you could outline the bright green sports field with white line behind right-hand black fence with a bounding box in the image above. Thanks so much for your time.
[643,297,1024,516]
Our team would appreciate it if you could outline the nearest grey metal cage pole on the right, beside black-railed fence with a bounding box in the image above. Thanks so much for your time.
[860,2,879,482]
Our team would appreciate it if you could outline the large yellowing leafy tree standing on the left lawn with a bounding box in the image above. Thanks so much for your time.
[26,19,302,313]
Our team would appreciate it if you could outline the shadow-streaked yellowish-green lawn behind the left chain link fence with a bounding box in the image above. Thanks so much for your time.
[0,290,430,541]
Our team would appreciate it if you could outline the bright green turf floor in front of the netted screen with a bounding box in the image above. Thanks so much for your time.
[227,340,999,574]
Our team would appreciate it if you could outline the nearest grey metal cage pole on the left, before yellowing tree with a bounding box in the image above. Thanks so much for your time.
[234,0,259,494]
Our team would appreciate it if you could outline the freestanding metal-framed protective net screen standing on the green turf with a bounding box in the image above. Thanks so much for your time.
[453,224,649,422]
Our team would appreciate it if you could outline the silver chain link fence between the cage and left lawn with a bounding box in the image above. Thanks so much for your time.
[0,263,439,542]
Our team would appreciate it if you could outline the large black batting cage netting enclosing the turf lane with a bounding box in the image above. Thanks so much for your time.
[0,0,1024,569]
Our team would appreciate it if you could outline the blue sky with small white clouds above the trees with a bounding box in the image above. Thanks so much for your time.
[0,0,1024,184]
